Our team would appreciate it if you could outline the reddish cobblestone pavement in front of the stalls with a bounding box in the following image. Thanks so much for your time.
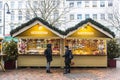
[0,68,120,80]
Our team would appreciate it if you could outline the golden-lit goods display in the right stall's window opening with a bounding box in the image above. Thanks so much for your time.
[66,39,106,55]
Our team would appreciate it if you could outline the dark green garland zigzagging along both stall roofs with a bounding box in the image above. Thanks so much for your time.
[10,17,115,37]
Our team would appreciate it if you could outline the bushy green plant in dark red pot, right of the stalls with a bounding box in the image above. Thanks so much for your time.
[107,39,120,67]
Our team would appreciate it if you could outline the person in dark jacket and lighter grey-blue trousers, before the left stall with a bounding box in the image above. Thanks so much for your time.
[44,44,52,73]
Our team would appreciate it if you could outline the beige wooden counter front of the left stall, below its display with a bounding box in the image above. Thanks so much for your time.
[17,54,62,67]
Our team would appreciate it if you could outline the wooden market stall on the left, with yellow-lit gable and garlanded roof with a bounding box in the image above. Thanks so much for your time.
[11,17,63,67]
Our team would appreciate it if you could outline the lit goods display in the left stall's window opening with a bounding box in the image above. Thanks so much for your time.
[18,39,60,55]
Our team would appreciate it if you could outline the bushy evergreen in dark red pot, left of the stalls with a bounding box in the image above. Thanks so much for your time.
[2,40,18,69]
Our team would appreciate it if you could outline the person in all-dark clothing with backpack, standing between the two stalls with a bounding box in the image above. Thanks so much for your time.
[63,46,73,74]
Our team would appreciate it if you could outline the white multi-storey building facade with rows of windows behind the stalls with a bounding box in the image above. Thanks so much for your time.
[0,0,120,37]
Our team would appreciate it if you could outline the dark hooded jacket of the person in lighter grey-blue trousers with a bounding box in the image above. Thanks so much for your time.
[44,44,52,62]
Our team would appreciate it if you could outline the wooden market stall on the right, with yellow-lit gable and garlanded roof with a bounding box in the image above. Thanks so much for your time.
[65,19,114,67]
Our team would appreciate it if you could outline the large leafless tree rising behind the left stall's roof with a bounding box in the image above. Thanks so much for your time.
[27,0,70,26]
